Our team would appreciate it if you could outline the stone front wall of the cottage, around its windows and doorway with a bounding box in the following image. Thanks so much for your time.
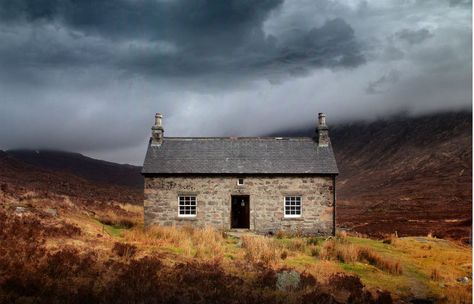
[144,176,335,235]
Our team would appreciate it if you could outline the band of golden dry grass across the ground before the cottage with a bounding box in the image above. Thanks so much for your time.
[0,194,471,303]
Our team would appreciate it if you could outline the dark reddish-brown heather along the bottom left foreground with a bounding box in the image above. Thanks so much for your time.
[0,212,392,303]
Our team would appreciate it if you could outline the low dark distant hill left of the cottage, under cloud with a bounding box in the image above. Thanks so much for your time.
[6,150,143,189]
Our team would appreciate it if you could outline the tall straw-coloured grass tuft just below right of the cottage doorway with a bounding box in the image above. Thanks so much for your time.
[241,236,282,266]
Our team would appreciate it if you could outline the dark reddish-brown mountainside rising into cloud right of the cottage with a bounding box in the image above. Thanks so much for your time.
[272,111,472,239]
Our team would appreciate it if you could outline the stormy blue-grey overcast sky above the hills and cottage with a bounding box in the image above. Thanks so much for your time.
[0,0,472,164]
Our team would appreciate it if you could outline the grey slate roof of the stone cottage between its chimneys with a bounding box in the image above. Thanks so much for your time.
[142,137,338,175]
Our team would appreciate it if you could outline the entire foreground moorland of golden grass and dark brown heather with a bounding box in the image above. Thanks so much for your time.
[0,193,471,303]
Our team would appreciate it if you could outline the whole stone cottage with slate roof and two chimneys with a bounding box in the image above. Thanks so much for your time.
[142,113,338,235]
